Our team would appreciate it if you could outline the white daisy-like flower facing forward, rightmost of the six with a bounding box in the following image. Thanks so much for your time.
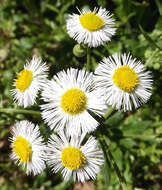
[95,54,152,111]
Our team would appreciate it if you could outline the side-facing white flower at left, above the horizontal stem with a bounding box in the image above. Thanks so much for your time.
[11,56,48,108]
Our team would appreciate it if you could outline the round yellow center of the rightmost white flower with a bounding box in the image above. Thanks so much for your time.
[113,65,139,92]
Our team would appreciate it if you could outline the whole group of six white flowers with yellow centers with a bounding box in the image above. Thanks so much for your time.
[10,8,152,182]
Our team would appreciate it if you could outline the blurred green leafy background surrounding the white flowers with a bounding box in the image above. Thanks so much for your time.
[0,0,162,190]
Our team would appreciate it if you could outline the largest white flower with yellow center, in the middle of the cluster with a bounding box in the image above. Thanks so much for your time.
[41,68,107,134]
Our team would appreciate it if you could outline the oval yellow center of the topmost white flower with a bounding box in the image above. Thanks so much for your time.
[79,12,104,31]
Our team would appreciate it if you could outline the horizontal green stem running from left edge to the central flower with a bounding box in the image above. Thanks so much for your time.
[0,108,40,116]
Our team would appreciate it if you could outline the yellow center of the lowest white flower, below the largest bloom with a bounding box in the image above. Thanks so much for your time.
[61,147,86,170]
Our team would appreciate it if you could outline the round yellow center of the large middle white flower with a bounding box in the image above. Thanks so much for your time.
[60,88,87,115]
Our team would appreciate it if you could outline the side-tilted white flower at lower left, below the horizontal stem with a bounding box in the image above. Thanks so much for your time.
[9,120,46,175]
